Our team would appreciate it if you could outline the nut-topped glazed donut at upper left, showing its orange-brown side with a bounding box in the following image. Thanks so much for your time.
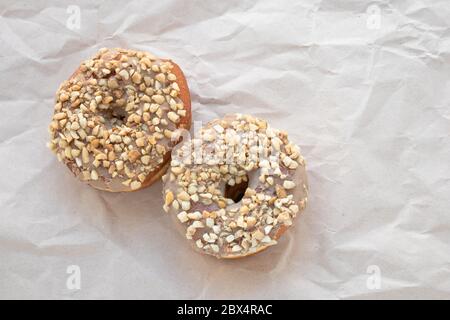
[48,49,191,192]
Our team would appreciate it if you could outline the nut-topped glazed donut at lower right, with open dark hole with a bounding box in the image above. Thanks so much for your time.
[163,114,308,259]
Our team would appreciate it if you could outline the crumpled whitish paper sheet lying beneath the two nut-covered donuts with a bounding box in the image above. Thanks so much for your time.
[0,0,450,299]
